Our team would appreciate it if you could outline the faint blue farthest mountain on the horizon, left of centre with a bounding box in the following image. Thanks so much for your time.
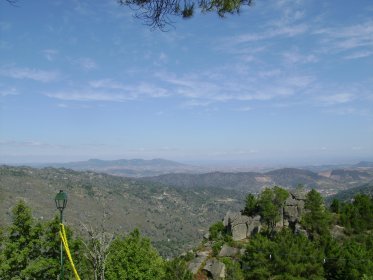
[34,159,199,177]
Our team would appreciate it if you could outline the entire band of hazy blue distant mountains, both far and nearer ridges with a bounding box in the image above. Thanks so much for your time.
[31,159,373,196]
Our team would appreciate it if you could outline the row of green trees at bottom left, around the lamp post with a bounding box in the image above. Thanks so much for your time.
[0,200,192,280]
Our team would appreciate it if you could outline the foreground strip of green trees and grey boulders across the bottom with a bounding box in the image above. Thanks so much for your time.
[0,187,373,280]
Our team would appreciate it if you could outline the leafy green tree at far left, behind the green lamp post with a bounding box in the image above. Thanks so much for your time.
[0,201,90,280]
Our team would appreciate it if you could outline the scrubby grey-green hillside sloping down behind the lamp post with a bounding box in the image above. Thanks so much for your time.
[0,166,244,256]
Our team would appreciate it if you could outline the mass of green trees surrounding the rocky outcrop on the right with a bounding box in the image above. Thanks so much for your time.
[198,187,373,280]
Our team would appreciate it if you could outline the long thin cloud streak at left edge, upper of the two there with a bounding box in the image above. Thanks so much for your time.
[0,67,59,83]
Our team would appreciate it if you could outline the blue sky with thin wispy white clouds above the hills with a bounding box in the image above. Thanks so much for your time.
[0,0,373,165]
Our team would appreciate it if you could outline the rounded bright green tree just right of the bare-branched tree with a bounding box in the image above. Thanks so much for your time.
[105,229,164,280]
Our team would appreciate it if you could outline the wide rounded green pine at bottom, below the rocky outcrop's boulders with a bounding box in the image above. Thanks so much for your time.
[243,229,324,279]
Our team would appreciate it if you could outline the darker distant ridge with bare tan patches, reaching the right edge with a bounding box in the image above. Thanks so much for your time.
[142,168,373,196]
